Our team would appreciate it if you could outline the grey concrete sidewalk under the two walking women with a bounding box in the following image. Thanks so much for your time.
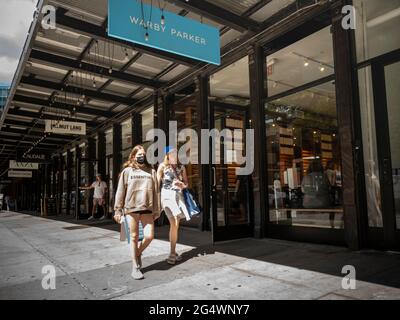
[0,212,400,300]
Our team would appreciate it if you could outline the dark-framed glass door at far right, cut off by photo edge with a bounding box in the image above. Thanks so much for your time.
[371,52,400,249]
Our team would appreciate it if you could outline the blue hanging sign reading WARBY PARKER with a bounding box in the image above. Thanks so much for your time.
[108,0,221,65]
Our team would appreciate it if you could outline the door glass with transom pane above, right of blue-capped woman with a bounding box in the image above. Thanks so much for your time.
[209,56,252,228]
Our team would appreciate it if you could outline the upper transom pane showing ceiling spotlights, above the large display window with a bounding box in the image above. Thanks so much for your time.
[266,26,334,97]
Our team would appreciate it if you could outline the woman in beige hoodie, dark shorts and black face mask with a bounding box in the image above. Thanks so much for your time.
[114,146,160,280]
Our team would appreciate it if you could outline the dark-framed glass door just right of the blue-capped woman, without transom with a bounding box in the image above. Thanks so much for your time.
[210,105,253,242]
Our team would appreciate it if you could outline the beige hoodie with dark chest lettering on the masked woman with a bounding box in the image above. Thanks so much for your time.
[114,167,160,218]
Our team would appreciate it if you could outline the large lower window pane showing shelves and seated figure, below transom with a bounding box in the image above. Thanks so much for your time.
[266,83,344,228]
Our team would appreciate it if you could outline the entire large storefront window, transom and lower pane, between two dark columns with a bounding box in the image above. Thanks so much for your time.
[265,27,344,229]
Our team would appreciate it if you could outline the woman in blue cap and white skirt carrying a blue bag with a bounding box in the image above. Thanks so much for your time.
[157,147,190,265]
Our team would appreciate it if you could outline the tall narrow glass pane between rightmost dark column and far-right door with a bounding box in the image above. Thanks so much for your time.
[358,67,383,228]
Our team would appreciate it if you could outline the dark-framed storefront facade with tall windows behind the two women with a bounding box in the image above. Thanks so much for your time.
[0,0,400,250]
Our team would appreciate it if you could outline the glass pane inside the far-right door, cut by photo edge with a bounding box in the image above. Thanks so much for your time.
[385,62,400,229]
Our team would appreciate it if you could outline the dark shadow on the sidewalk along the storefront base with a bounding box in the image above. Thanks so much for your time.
[14,210,400,288]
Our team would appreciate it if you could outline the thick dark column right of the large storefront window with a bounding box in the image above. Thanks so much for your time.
[332,0,365,250]
